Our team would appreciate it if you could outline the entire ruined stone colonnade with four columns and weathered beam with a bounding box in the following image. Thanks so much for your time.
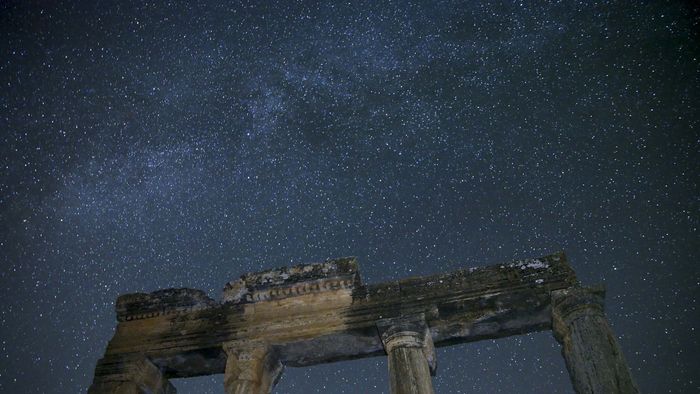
[88,253,637,394]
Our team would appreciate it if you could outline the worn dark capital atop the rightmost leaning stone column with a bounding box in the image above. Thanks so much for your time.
[551,285,605,342]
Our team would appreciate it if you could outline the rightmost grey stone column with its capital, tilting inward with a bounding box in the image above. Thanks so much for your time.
[552,286,639,394]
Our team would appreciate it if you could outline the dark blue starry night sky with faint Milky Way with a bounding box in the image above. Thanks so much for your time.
[0,0,700,393]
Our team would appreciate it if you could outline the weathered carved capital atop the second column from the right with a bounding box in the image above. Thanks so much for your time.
[377,313,437,376]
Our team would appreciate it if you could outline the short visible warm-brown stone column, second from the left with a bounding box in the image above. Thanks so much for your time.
[223,341,284,394]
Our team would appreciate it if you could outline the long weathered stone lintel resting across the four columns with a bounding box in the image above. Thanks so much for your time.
[94,253,578,377]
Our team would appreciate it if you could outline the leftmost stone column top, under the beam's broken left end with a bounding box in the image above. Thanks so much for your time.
[88,357,177,394]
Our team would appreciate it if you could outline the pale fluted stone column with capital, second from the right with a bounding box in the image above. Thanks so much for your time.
[377,316,436,394]
